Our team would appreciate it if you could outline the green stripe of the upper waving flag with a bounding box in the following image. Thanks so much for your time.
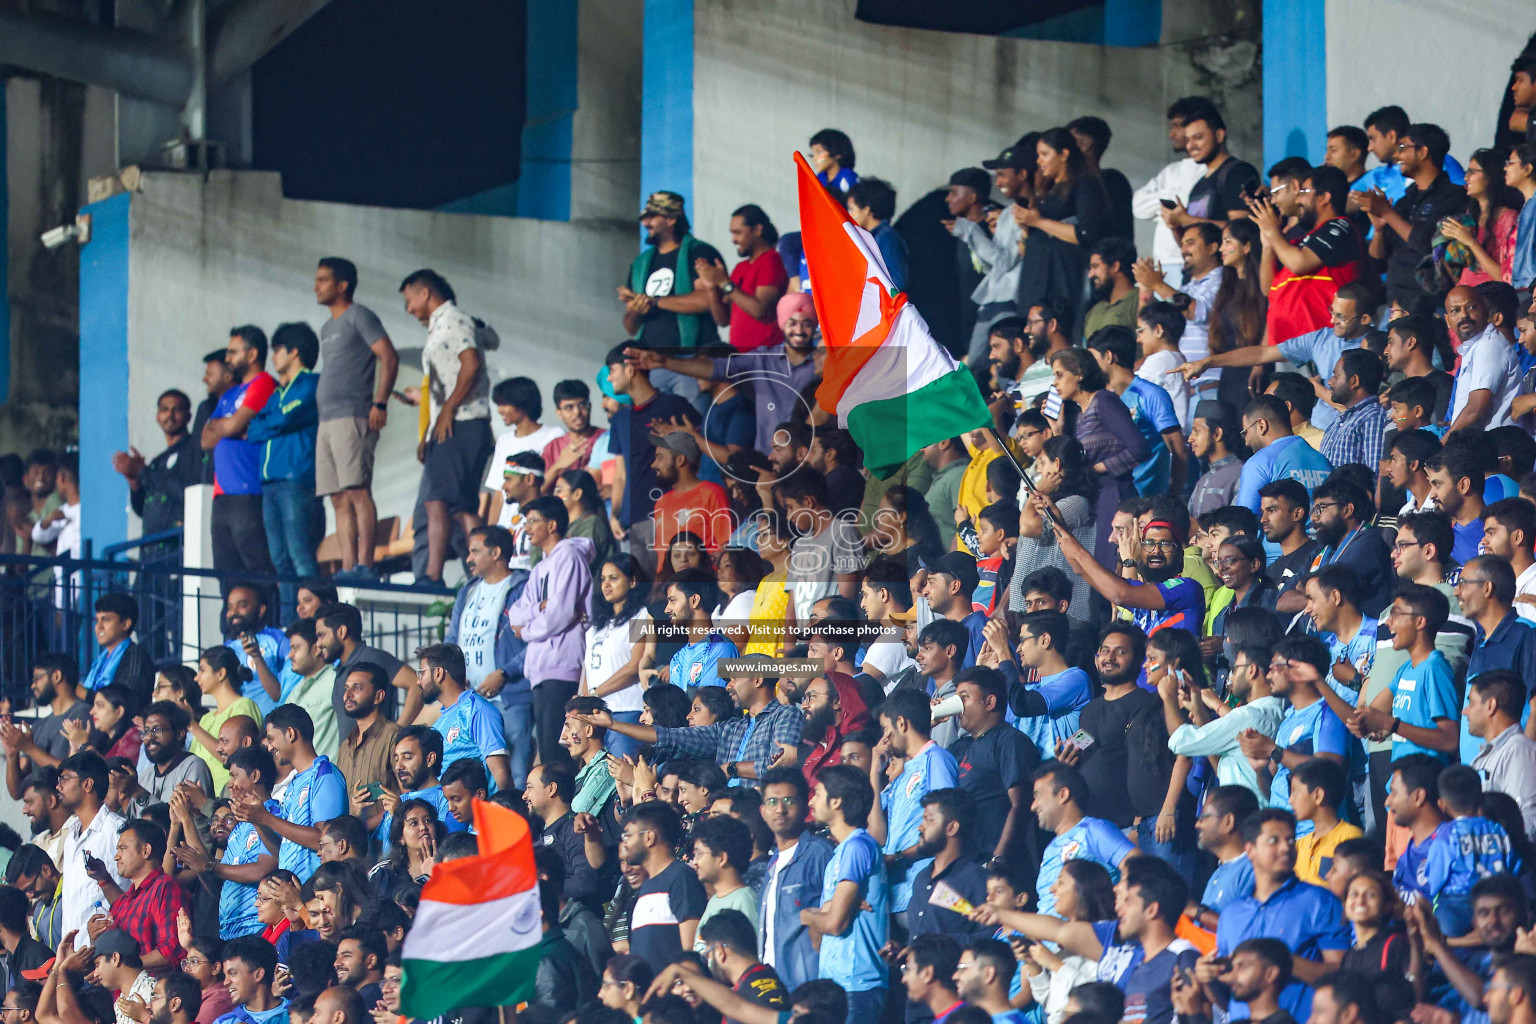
[848,365,992,479]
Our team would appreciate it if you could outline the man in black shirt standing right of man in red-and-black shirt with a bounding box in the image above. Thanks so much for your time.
[1356,123,1467,313]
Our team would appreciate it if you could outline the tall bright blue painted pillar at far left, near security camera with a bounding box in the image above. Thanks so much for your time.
[80,192,132,551]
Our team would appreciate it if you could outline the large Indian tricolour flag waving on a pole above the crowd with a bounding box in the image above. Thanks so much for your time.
[794,154,992,477]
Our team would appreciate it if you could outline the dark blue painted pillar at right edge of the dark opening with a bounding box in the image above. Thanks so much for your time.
[518,0,579,221]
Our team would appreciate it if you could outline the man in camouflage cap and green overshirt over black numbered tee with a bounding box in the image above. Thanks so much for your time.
[619,192,724,356]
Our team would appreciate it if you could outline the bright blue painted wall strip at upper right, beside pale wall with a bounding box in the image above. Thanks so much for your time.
[1260,0,1329,173]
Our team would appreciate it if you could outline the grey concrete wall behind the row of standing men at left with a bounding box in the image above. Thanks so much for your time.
[111,172,634,545]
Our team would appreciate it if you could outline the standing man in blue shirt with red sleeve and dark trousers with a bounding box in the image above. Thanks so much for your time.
[200,324,278,593]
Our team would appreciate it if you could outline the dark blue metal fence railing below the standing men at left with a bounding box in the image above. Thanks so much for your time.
[0,549,453,706]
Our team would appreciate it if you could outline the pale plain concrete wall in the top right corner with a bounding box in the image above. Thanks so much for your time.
[1318,0,1536,163]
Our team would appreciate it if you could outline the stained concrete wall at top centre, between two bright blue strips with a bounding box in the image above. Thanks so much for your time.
[688,0,1260,260]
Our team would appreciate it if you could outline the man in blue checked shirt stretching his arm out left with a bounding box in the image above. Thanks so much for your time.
[570,654,805,788]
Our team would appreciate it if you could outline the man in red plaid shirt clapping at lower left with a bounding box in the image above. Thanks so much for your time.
[94,818,186,973]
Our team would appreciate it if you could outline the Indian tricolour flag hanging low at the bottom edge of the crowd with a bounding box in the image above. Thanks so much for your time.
[399,800,544,1021]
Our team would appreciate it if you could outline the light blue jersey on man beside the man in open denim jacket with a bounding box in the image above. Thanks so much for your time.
[817,829,891,992]
